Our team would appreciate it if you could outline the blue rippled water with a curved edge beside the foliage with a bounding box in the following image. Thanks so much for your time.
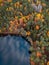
[0,35,30,65]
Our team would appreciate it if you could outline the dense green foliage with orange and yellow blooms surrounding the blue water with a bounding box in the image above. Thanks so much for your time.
[0,0,49,65]
